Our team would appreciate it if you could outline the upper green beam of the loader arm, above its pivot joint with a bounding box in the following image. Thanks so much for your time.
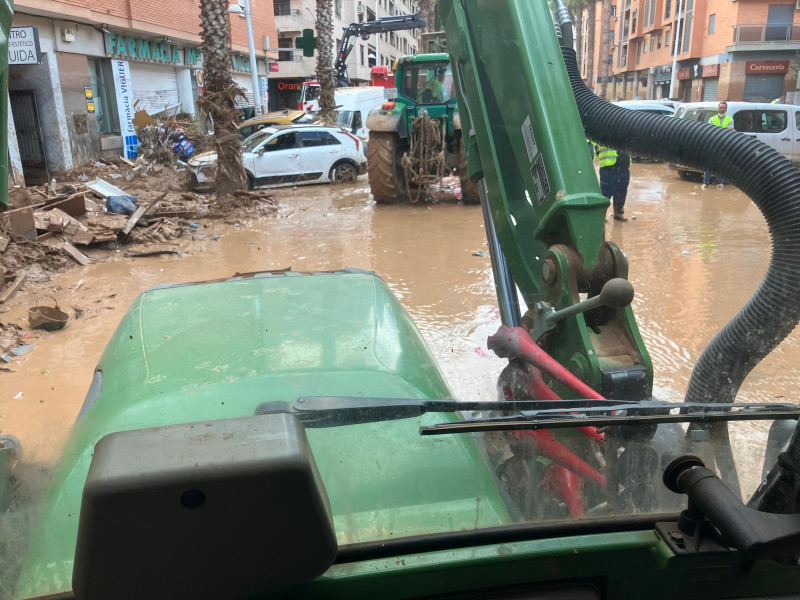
[441,0,608,306]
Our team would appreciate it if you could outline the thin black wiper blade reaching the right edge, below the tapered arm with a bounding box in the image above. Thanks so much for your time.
[419,402,800,435]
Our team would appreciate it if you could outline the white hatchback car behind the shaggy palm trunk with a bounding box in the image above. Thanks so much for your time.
[188,125,367,192]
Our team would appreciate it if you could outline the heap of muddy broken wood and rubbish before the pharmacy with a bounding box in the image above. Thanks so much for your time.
[0,157,277,305]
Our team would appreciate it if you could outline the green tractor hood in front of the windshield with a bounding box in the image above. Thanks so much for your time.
[19,273,509,597]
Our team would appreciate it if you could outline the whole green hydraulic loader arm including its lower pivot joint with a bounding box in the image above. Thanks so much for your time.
[440,0,652,399]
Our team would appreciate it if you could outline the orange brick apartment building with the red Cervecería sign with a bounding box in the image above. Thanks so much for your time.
[582,0,800,102]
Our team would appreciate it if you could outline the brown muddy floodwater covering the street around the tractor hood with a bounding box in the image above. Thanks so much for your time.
[0,164,800,490]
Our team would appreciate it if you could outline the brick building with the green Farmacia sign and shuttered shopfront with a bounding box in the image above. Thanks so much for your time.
[9,0,277,184]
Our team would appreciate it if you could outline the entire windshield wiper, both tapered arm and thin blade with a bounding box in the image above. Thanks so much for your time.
[256,396,800,435]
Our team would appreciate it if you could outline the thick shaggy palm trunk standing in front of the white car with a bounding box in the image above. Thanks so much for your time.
[197,0,245,197]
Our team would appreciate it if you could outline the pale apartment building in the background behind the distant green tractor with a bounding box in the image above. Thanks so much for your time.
[269,0,417,110]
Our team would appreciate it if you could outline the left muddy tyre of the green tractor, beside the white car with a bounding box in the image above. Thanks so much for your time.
[367,131,408,204]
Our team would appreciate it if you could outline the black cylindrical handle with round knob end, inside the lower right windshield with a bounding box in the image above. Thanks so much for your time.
[664,455,800,571]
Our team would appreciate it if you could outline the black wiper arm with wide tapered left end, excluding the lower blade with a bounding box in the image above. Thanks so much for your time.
[256,396,638,428]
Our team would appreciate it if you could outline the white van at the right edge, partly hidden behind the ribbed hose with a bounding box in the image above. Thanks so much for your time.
[669,102,800,176]
